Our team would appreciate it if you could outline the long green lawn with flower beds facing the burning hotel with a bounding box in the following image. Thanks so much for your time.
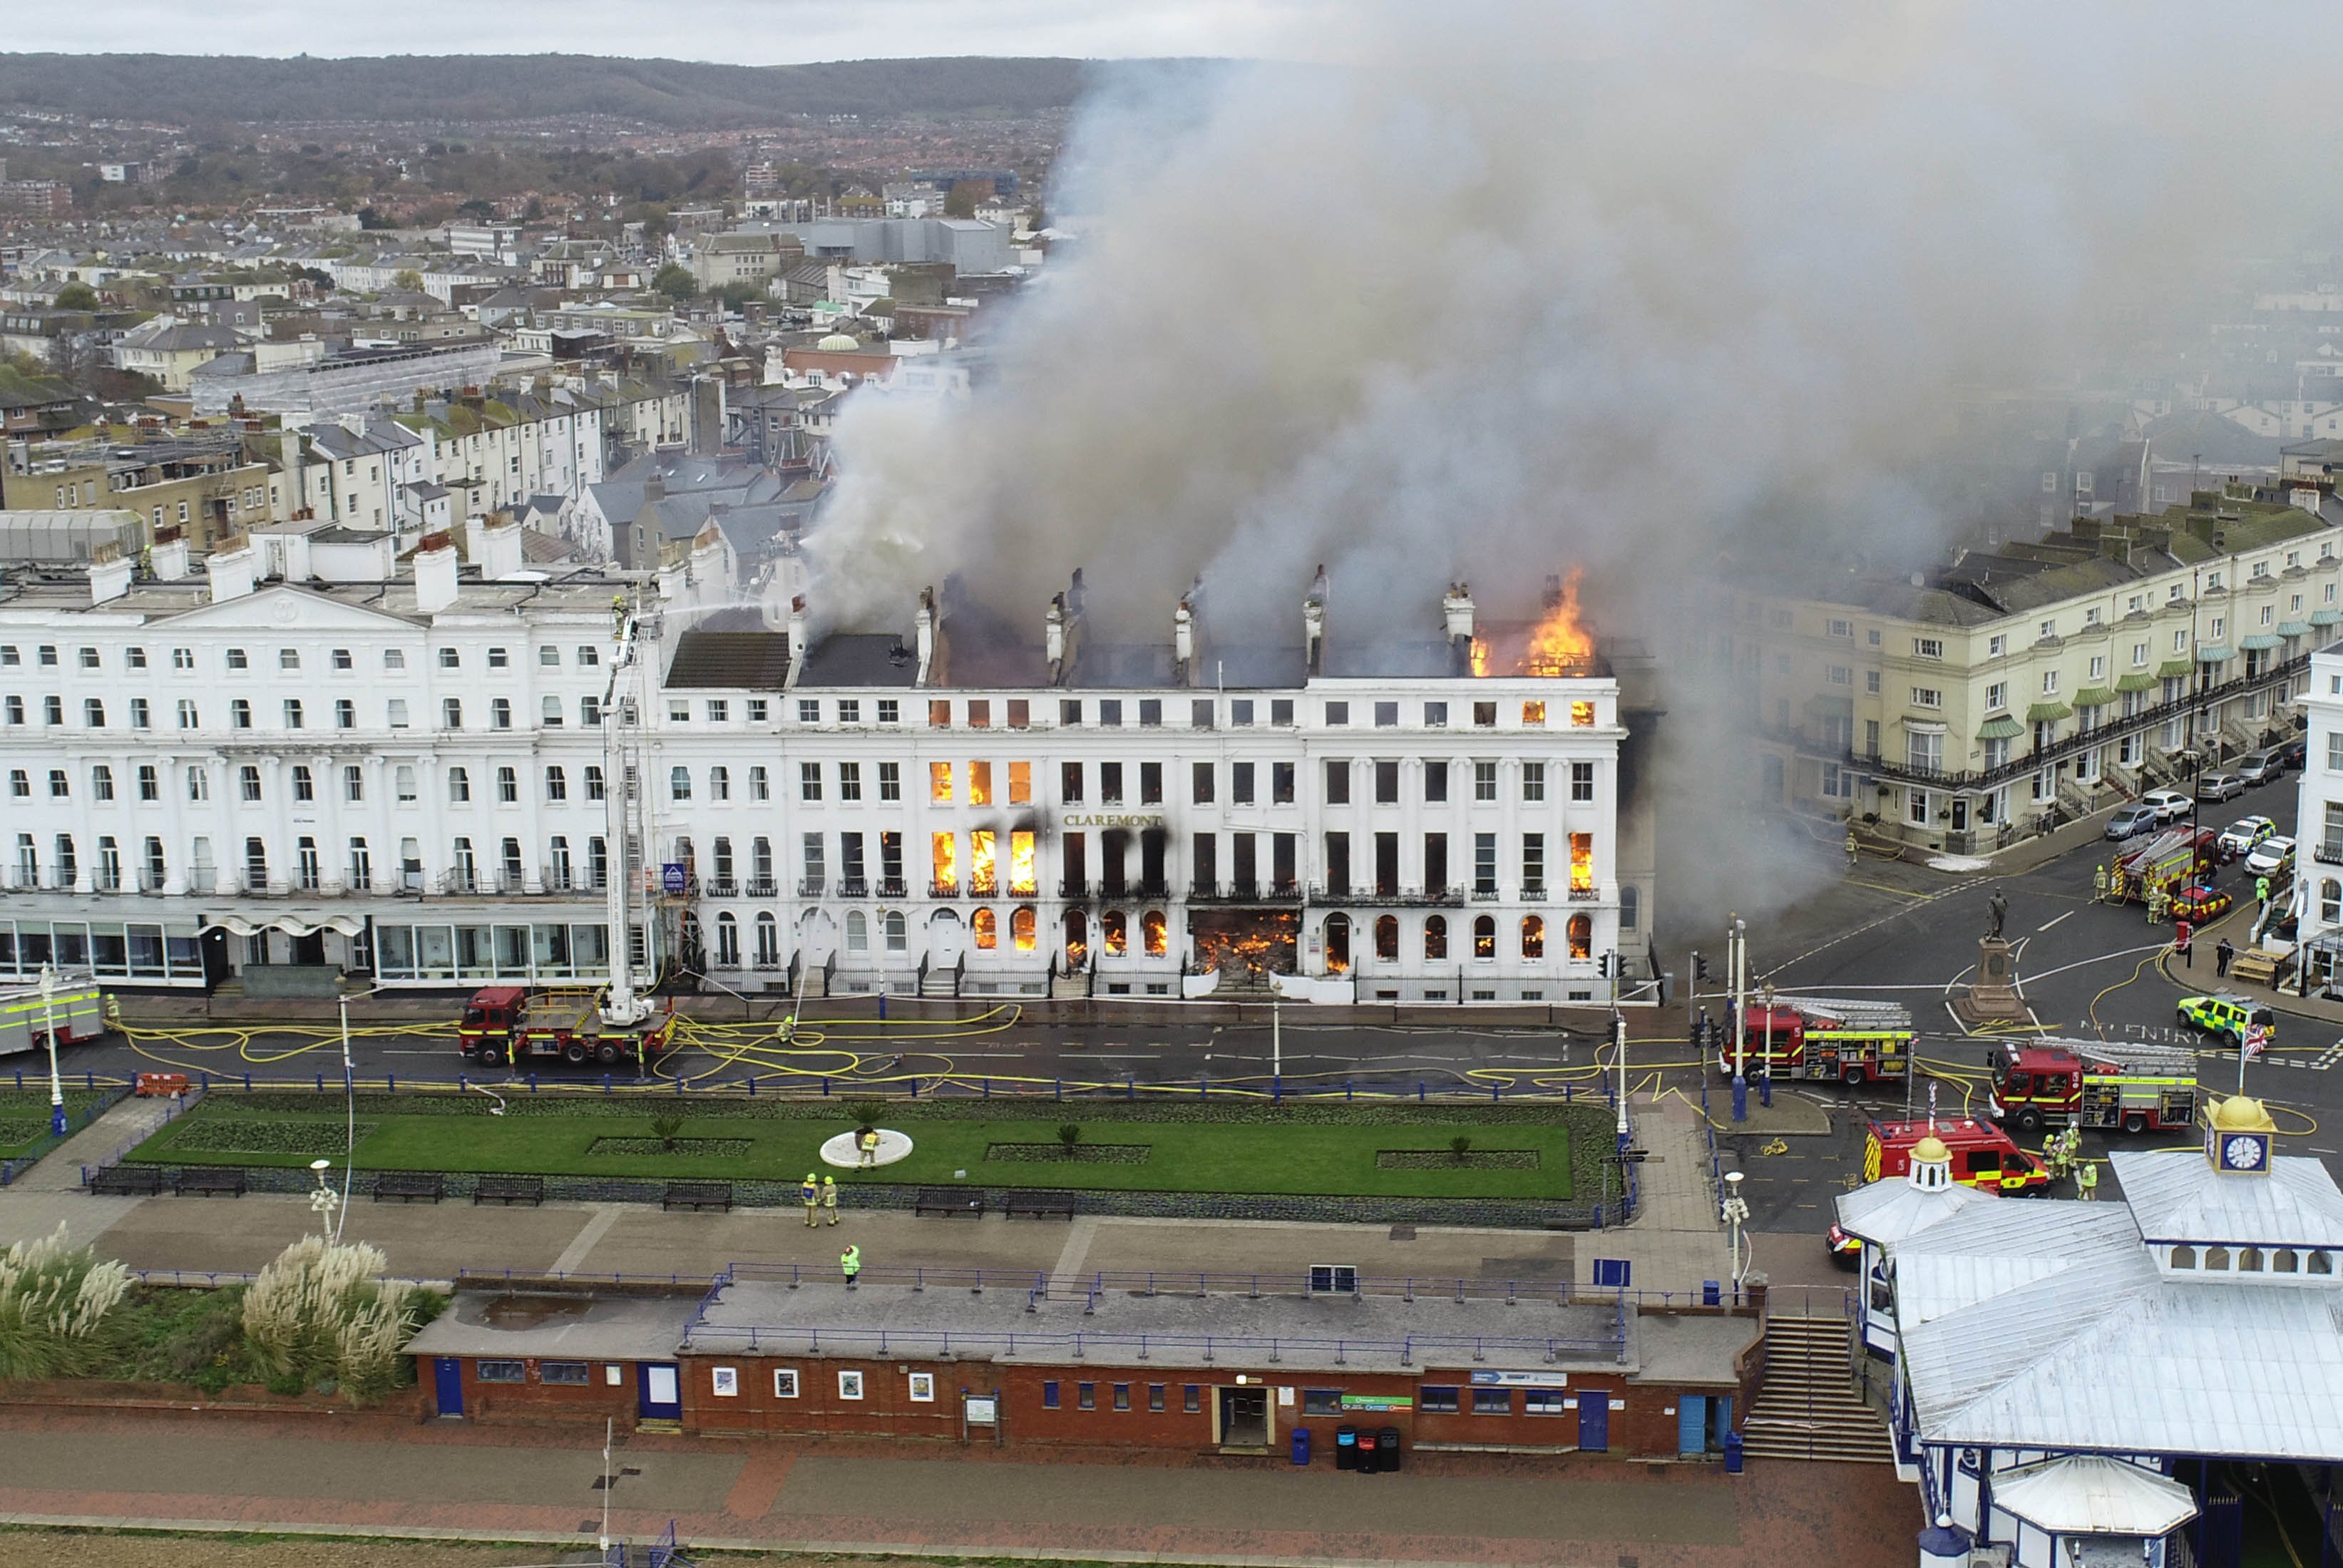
[131,1097,1574,1200]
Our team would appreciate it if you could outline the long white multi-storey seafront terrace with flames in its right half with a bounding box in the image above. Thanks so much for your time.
[0,530,1652,1003]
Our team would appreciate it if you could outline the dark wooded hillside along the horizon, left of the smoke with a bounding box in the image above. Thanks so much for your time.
[0,54,1124,129]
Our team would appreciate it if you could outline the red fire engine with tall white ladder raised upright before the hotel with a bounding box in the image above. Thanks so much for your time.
[457,603,675,1071]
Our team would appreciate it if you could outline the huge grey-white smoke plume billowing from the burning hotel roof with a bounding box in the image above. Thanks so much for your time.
[811,0,2343,928]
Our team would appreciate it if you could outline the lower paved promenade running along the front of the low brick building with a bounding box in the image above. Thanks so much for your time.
[0,1408,1919,1568]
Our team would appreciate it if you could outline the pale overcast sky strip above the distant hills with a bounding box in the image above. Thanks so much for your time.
[0,0,1340,66]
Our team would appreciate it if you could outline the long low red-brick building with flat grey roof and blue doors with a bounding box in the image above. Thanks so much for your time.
[410,1266,1762,1462]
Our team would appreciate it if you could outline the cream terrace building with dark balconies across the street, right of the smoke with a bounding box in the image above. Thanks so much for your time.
[1708,483,2343,853]
